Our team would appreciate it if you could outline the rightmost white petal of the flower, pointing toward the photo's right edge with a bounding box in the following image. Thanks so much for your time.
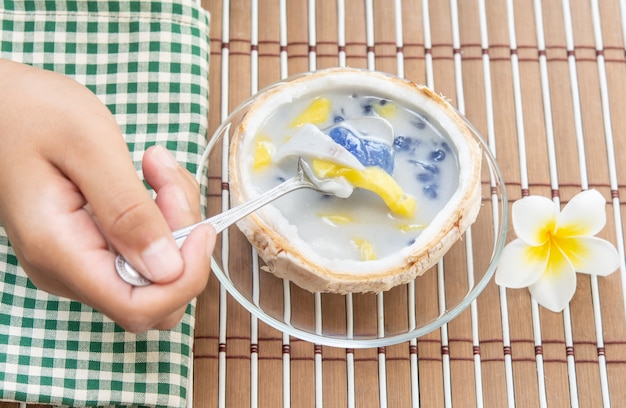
[559,237,620,276]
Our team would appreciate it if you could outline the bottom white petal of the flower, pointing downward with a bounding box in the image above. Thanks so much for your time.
[528,241,576,312]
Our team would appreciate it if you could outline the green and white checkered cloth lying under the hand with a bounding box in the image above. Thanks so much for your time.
[0,0,209,407]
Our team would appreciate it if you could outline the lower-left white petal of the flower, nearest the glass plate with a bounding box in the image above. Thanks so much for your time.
[496,239,548,289]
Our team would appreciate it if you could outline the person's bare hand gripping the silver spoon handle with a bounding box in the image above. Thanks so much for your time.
[0,60,215,332]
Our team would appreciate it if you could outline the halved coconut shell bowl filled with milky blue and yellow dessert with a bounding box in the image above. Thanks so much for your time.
[229,69,482,293]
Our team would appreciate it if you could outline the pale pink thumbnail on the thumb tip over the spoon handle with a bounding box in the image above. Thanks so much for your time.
[141,237,183,282]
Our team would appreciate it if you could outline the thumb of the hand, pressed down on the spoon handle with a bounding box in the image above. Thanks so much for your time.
[64,127,184,283]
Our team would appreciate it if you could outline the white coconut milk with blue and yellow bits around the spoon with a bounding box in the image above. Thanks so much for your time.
[241,90,459,260]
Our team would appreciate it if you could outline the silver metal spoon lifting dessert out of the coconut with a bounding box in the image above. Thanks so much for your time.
[115,158,354,286]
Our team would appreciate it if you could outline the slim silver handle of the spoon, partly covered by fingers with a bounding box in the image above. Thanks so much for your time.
[115,169,315,286]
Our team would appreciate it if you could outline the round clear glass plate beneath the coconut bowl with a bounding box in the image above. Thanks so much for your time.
[202,71,508,348]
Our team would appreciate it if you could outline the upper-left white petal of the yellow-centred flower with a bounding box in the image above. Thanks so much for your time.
[511,196,559,246]
